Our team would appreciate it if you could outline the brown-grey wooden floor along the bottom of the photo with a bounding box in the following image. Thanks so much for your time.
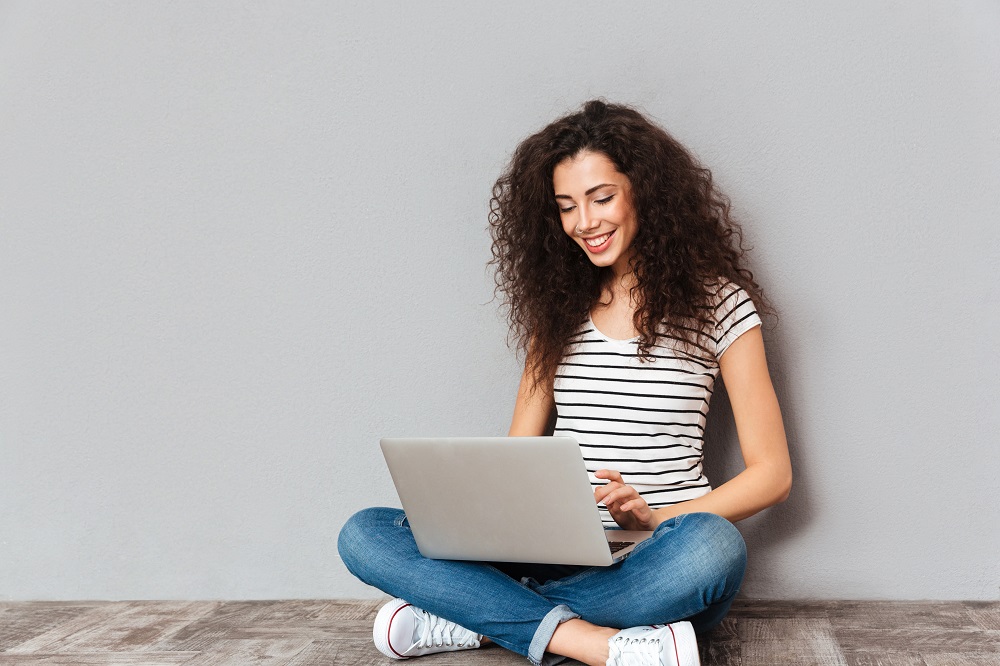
[0,600,1000,666]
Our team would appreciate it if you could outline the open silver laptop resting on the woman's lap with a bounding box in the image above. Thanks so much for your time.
[381,437,652,566]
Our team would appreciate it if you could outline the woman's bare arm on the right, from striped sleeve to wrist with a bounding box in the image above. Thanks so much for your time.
[653,327,792,526]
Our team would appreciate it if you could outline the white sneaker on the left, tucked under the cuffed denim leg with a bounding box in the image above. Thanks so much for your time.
[372,599,482,659]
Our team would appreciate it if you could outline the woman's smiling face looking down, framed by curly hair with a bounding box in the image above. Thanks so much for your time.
[552,151,638,276]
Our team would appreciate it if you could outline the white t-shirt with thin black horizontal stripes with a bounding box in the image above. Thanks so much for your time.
[553,282,761,526]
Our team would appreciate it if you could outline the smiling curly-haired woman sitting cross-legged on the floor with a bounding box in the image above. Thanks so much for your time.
[339,101,791,666]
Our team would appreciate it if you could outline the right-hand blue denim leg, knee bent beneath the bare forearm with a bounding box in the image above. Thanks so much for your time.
[532,513,746,632]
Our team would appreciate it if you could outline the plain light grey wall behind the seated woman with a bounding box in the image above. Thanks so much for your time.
[0,0,1000,599]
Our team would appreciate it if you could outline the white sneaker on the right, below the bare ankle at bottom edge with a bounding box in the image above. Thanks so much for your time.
[607,622,701,666]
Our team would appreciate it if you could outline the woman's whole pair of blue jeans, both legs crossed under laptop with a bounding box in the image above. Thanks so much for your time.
[337,508,746,665]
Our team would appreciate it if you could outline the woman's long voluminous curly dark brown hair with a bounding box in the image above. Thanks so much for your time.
[489,100,774,386]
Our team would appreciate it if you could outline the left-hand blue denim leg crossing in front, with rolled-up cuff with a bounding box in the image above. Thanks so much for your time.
[337,508,579,664]
